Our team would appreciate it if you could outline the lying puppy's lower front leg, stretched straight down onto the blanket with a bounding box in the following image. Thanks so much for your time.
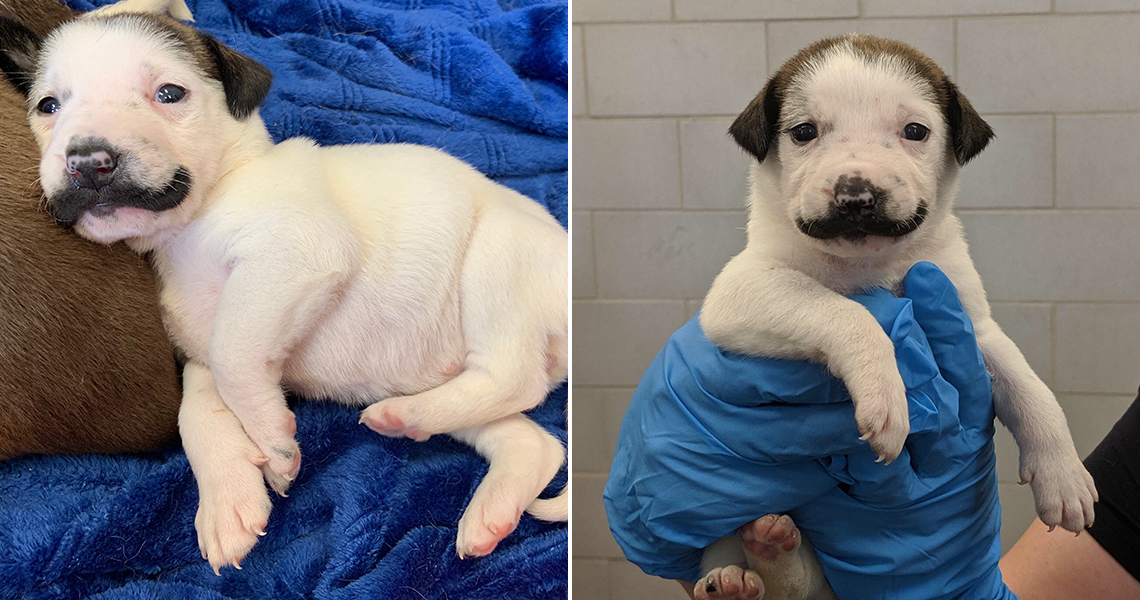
[178,363,272,573]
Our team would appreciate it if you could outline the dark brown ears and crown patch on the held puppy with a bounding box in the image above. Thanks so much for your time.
[728,34,994,165]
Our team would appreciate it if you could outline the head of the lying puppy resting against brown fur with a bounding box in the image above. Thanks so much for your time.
[0,14,271,243]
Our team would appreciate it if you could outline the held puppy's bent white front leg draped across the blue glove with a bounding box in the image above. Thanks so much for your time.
[701,250,910,461]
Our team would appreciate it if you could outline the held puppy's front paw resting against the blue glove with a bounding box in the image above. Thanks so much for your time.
[846,371,911,464]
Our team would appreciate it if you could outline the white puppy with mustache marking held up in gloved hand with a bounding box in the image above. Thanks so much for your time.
[698,35,1097,599]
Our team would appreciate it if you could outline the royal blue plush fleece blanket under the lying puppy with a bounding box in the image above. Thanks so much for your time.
[0,0,569,600]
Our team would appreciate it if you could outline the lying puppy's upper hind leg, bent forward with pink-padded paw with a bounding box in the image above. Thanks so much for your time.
[361,209,568,439]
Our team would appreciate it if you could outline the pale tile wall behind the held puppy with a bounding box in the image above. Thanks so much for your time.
[573,0,1140,600]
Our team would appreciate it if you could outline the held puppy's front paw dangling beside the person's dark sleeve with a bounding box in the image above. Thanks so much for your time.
[1020,448,1100,534]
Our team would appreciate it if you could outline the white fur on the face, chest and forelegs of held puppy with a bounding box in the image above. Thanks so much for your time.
[701,39,1097,599]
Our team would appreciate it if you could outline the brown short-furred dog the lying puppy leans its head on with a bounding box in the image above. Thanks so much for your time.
[0,0,180,459]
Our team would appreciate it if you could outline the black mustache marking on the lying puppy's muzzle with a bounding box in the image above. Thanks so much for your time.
[48,167,194,227]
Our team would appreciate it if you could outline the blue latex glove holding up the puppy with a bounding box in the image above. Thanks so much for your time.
[604,262,1015,600]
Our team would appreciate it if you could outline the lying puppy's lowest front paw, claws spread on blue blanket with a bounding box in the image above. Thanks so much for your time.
[194,462,272,575]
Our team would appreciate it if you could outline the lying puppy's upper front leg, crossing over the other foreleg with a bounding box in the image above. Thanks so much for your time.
[210,258,345,495]
